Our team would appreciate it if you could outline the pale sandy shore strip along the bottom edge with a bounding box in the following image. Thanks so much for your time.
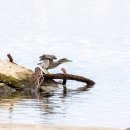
[0,123,125,130]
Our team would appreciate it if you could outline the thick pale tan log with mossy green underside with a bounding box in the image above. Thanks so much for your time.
[0,60,33,89]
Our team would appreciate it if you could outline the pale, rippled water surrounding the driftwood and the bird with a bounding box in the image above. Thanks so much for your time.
[0,0,130,128]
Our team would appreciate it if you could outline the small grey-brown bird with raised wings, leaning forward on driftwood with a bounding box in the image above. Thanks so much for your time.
[38,54,71,74]
